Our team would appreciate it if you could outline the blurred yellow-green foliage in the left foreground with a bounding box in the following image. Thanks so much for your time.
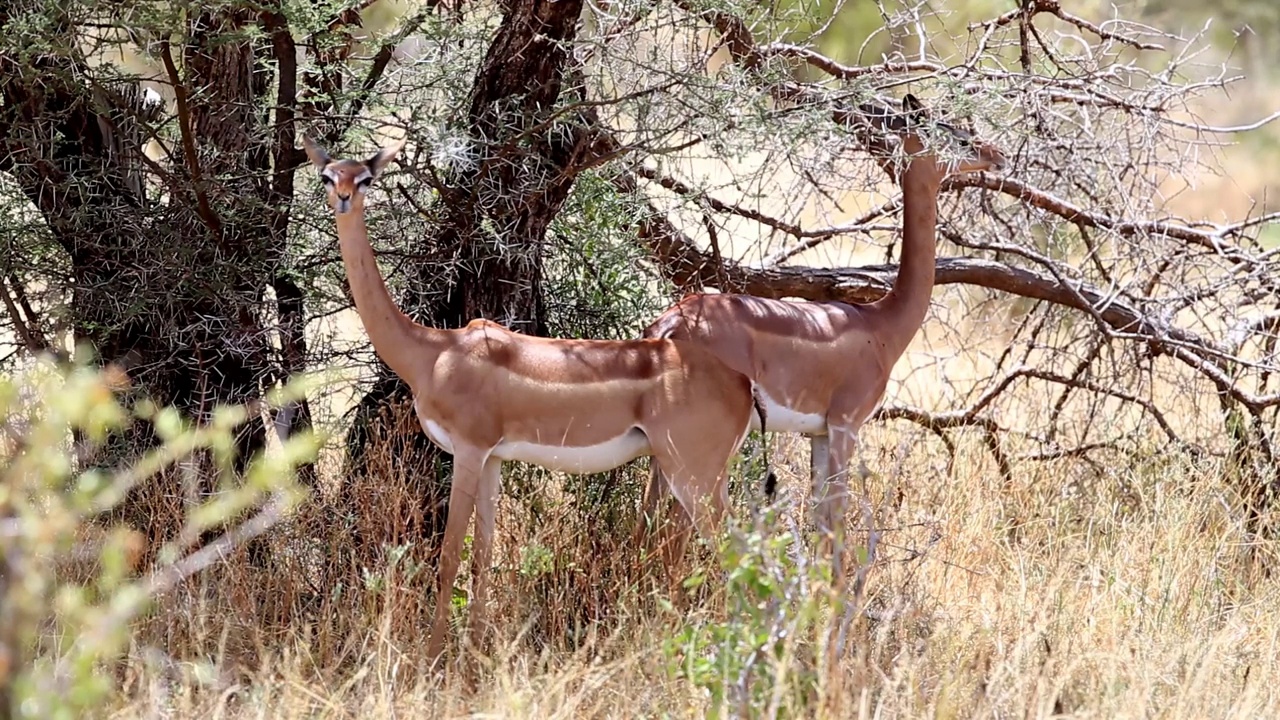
[0,358,319,717]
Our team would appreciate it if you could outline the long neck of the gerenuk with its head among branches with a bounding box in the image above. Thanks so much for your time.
[874,155,941,360]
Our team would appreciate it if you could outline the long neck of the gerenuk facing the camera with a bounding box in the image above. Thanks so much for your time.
[337,195,430,384]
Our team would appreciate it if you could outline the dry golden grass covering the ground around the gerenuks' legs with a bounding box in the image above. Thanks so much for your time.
[97,412,1280,717]
